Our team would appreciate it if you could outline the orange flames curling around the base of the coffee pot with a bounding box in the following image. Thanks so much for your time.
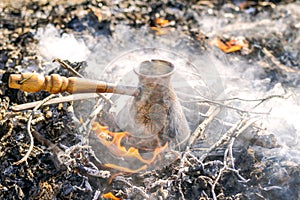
[92,122,168,173]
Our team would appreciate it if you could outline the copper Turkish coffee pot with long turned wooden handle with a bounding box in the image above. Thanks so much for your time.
[8,59,190,150]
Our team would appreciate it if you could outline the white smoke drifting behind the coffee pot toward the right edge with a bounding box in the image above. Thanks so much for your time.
[37,20,300,197]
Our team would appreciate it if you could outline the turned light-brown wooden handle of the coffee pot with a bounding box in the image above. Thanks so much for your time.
[8,73,115,94]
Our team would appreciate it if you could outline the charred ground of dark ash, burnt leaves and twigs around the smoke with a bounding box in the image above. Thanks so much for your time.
[0,0,300,199]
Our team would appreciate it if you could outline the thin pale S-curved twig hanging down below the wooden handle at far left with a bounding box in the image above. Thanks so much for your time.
[13,94,56,165]
